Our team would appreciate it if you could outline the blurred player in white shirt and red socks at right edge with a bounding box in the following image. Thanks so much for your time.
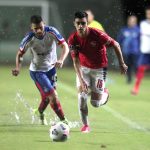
[132,6,150,95]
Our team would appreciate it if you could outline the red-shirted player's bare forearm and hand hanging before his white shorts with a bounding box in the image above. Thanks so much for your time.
[73,57,88,93]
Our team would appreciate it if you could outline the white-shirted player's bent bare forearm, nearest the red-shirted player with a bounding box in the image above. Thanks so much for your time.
[55,42,69,68]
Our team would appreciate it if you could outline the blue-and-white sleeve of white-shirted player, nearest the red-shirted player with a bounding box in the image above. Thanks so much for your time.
[47,27,65,45]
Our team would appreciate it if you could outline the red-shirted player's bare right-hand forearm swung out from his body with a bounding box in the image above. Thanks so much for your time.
[113,42,128,74]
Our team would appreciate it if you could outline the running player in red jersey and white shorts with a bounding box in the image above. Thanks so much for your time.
[68,12,127,133]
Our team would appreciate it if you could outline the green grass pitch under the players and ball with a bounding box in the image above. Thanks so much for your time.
[0,66,150,150]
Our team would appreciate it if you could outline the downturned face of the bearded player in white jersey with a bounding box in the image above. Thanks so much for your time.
[31,22,44,37]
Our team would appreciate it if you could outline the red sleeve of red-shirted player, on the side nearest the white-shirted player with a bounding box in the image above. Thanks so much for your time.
[68,35,79,58]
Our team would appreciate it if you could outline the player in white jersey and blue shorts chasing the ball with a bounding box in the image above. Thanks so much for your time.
[12,15,69,124]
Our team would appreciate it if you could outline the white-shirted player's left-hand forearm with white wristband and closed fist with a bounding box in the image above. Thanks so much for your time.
[12,50,23,76]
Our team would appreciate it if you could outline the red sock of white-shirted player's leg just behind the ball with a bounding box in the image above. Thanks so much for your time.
[50,100,65,120]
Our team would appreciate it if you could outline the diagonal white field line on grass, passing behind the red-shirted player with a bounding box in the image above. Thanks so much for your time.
[59,81,148,132]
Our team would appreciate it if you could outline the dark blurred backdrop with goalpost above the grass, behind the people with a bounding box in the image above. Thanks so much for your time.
[0,0,148,67]
